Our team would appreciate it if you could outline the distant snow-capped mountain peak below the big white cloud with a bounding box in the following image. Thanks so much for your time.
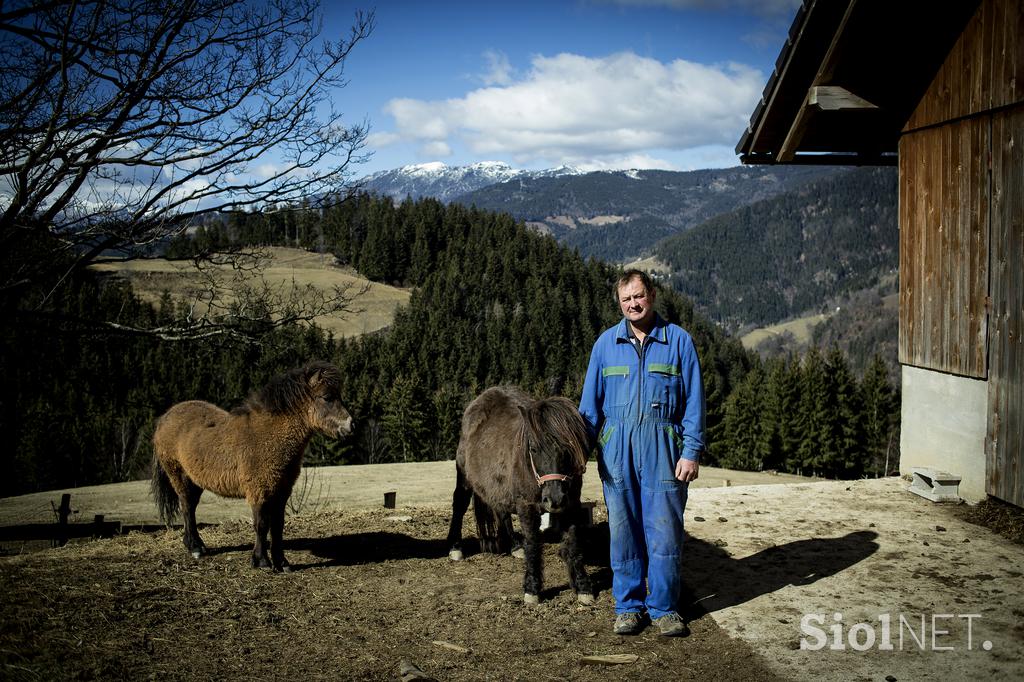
[359,161,583,203]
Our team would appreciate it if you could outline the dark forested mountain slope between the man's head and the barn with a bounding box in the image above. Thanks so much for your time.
[654,168,899,330]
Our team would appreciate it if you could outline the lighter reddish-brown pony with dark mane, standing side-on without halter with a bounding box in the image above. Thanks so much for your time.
[153,361,352,570]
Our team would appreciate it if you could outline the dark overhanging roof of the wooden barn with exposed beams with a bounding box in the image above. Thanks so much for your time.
[736,0,979,165]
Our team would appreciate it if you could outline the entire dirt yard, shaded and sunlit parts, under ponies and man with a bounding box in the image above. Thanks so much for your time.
[0,463,1024,681]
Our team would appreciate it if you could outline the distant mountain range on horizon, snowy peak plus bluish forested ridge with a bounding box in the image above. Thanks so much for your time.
[362,162,845,262]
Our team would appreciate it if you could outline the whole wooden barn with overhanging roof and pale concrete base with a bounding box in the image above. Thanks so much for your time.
[736,0,1024,506]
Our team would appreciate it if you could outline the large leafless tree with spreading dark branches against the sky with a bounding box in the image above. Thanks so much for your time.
[0,0,374,335]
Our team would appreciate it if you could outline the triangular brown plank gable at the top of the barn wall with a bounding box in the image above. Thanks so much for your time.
[903,0,1024,131]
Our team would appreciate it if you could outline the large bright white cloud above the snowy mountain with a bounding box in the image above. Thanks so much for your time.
[385,52,764,167]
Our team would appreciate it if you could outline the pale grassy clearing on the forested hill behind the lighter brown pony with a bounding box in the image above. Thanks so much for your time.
[93,247,410,336]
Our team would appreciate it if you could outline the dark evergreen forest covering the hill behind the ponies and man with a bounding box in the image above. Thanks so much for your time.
[0,189,898,496]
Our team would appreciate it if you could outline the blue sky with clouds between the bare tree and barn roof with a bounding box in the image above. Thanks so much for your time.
[325,0,800,175]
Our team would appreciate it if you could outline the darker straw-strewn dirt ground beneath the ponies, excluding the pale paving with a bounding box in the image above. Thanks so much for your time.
[0,501,775,680]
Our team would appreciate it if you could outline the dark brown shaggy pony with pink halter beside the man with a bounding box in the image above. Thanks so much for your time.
[447,386,594,604]
